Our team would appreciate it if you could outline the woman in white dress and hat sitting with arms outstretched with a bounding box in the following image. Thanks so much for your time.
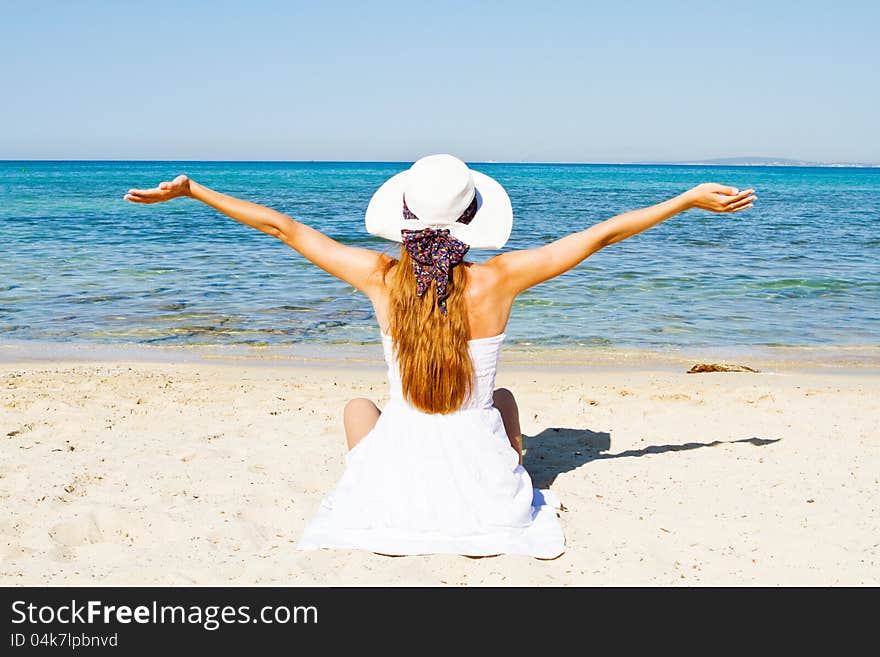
[125,155,755,558]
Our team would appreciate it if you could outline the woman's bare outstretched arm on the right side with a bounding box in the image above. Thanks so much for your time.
[485,183,757,297]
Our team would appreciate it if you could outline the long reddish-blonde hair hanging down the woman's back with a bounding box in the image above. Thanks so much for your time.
[385,245,474,414]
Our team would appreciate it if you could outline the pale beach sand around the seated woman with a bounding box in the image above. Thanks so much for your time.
[0,352,880,585]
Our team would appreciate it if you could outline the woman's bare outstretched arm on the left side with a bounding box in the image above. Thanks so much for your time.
[125,176,392,296]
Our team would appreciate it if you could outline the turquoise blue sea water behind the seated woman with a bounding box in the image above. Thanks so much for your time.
[0,161,880,348]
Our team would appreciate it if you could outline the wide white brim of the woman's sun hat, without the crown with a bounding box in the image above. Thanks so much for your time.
[365,169,513,249]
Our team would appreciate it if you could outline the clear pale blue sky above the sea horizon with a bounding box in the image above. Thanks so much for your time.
[0,0,880,162]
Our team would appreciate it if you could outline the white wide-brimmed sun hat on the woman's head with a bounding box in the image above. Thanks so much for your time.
[366,155,513,249]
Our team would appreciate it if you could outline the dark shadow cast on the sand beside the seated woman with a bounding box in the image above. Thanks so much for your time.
[523,427,781,488]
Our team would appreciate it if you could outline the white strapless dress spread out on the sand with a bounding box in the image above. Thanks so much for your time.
[297,333,565,559]
